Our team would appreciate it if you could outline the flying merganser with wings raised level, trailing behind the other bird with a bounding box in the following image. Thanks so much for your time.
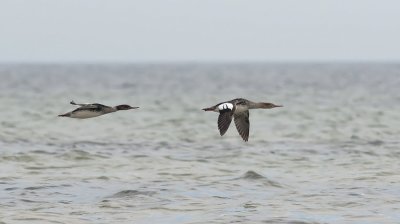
[58,101,139,119]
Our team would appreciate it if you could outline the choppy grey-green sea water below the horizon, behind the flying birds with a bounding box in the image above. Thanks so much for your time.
[0,64,400,224]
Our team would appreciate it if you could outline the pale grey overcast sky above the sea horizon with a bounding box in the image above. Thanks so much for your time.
[0,0,400,62]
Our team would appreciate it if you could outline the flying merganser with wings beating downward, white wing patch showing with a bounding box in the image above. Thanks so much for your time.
[203,98,282,142]
